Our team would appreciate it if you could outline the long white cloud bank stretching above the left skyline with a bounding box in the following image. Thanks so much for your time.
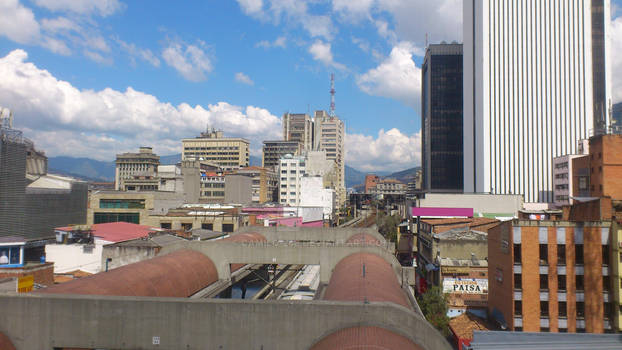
[0,50,281,160]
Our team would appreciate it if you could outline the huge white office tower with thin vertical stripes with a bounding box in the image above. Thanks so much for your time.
[463,0,611,202]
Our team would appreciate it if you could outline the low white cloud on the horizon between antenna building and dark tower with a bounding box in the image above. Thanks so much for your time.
[346,128,421,171]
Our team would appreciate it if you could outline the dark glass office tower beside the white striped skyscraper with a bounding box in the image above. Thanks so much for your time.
[421,44,464,192]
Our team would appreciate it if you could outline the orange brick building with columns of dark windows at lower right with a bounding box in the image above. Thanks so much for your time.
[488,219,618,333]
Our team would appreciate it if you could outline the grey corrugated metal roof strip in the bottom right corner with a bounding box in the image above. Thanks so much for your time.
[470,331,622,350]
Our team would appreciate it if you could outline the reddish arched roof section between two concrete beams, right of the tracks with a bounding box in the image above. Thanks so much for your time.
[324,253,411,308]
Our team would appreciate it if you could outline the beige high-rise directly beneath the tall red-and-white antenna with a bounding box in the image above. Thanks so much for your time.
[313,111,346,205]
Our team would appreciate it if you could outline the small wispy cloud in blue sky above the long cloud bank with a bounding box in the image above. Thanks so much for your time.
[162,41,213,82]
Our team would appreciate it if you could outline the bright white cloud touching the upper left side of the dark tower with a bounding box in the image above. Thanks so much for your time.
[356,42,421,110]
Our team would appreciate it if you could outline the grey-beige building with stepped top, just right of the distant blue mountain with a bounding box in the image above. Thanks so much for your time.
[114,147,160,191]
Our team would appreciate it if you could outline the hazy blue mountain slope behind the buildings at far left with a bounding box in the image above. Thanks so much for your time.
[48,156,115,182]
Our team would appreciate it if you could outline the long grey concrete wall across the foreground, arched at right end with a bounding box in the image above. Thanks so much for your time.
[0,294,451,350]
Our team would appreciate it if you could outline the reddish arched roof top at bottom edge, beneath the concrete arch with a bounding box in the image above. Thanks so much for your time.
[311,326,423,350]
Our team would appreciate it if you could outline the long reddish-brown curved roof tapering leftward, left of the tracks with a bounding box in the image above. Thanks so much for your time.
[38,249,218,297]
